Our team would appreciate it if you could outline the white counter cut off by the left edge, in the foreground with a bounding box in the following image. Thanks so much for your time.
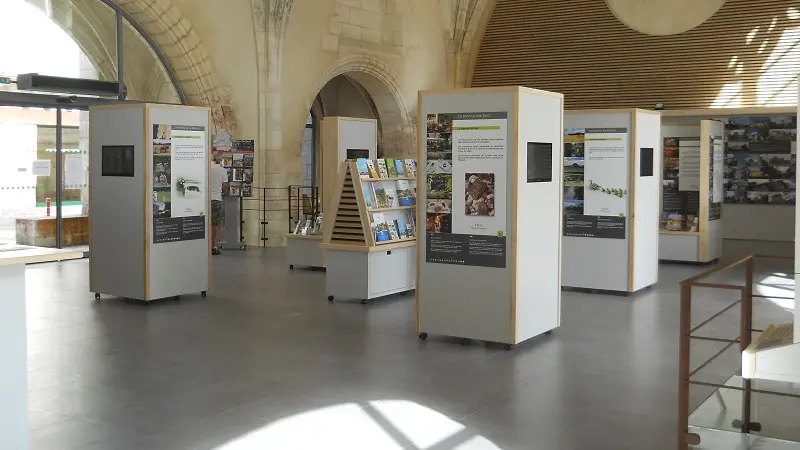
[0,245,83,450]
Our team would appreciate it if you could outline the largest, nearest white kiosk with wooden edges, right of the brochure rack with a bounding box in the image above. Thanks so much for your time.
[416,87,564,349]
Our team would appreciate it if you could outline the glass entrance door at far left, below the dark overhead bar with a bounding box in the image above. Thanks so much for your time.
[0,105,89,251]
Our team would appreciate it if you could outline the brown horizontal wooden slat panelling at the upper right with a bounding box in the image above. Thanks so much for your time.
[471,0,800,109]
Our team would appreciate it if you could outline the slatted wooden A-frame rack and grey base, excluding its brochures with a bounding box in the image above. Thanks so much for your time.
[320,160,417,304]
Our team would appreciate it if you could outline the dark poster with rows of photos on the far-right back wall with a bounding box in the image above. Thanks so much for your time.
[720,115,797,205]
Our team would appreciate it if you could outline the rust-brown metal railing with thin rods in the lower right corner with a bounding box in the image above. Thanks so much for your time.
[678,255,800,450]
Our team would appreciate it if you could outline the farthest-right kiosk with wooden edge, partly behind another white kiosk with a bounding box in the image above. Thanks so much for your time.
[658,119,725,264]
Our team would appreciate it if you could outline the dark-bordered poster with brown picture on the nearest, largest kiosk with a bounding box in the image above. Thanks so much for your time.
[424,112,508,268]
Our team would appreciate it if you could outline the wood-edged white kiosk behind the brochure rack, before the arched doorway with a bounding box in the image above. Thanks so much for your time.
[320,116,378,211]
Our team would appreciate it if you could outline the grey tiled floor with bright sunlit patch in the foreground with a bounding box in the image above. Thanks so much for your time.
[21,249,791,450]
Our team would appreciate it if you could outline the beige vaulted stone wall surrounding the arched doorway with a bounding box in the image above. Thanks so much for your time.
[30,0,494,245]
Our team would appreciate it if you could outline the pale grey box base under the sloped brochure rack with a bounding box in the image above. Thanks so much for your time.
[322,241,417,303]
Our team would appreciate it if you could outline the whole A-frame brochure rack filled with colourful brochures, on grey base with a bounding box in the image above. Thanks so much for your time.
[320,158,417,303]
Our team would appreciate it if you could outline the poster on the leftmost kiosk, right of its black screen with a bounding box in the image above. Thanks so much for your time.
[152,124,208,244]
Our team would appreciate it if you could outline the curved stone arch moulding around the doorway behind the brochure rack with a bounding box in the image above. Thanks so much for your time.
[298,54,416,156]
